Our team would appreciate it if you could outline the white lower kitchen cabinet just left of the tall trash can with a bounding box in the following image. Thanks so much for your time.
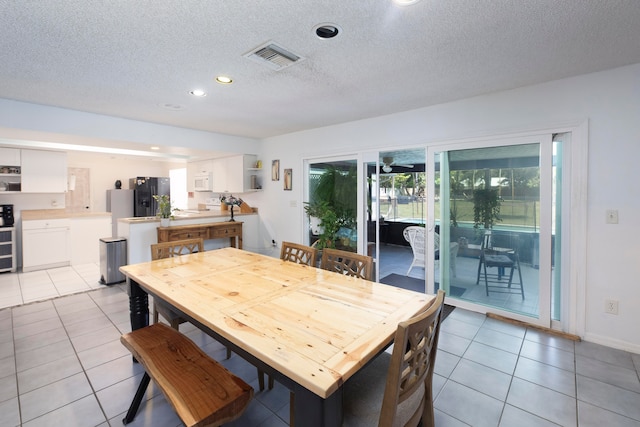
[71,217,112,264]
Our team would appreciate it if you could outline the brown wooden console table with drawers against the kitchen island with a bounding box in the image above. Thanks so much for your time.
[158,221,242,249]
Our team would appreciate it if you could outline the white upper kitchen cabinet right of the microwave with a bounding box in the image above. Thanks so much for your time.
[213,154,257,193]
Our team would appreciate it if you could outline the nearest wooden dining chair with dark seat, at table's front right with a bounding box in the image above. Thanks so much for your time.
[342,290,444,427]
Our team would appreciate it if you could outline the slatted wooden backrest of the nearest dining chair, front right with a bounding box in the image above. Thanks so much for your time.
[378,290,444,427]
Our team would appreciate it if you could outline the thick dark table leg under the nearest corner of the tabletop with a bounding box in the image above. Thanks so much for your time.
[294,385,342,427]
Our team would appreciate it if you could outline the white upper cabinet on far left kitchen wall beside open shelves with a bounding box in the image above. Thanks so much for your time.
[21,150,67,193]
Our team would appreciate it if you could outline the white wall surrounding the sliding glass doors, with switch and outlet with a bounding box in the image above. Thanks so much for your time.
[261,64,640,353]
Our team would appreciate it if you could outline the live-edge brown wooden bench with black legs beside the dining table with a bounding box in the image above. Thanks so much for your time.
[120,323,253,427]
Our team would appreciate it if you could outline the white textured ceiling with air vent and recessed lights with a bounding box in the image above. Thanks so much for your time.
[0,0,640,142]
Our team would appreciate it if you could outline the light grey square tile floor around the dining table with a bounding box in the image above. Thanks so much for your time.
[0,266,640,427]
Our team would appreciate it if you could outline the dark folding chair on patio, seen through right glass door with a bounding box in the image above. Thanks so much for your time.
[476,230,524,300]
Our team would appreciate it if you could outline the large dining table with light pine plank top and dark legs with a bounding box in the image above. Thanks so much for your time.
[120,248,434,427]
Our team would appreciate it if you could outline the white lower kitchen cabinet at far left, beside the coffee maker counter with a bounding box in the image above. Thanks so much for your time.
[22,218,71,272]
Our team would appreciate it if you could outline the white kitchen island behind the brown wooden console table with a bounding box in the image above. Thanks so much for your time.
[118,211,260,264]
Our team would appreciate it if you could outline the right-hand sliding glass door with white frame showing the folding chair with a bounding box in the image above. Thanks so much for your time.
[427,135,561,326]
